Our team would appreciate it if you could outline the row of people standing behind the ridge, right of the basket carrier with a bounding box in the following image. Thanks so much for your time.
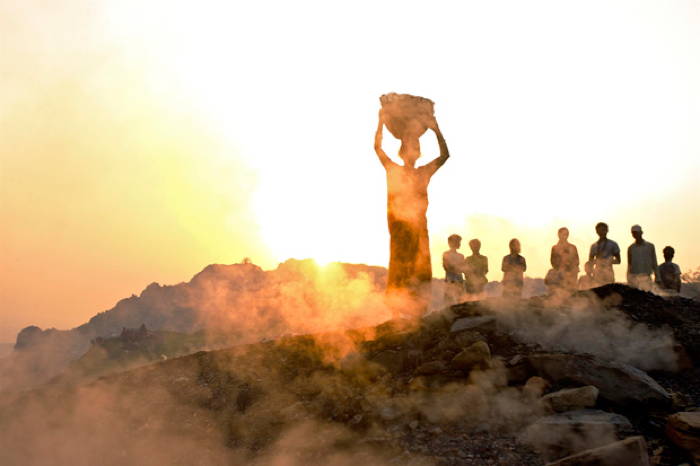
[442,222,681,302]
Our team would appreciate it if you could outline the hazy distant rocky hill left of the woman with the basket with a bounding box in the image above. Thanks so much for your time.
[0,260,387,392]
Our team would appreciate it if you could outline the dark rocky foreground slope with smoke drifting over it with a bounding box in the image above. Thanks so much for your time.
[0,278,700,465]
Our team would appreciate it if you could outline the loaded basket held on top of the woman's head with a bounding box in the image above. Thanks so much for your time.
[379,92,435,140]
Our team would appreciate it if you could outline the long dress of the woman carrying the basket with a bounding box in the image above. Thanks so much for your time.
[385,161,439,290]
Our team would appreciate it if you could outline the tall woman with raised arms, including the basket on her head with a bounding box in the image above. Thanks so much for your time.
[374,94,449,300]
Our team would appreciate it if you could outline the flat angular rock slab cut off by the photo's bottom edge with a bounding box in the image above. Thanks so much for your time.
[547,436,651,466]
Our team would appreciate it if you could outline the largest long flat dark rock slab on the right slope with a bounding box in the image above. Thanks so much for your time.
[528,353,671,404]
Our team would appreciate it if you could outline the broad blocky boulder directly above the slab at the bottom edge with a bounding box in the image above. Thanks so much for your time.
[521,409,632,461]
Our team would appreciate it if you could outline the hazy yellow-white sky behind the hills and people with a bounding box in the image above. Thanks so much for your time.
[0,0,700,341]
